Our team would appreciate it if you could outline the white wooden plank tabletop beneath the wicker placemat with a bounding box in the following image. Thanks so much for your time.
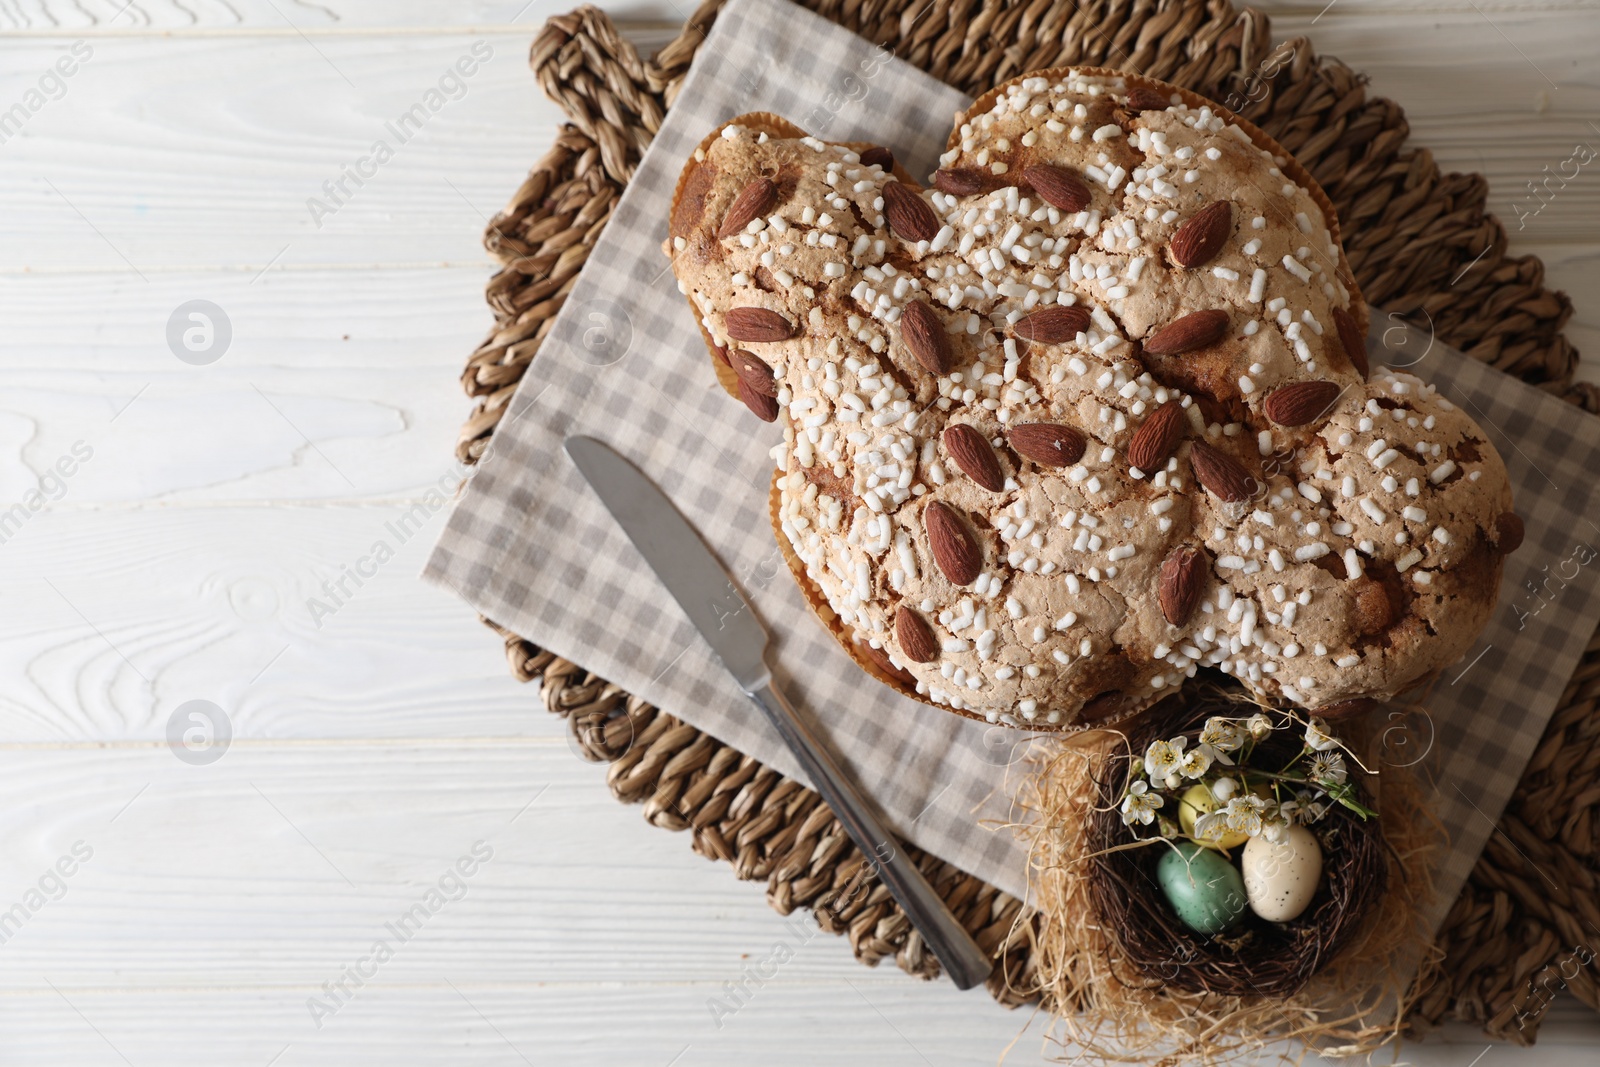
[0,0,1600,1067]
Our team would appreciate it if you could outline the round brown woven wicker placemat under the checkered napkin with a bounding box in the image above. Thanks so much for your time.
[456,0,1600,1043]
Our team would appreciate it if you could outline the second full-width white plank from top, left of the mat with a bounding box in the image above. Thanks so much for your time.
[0,266,493,509]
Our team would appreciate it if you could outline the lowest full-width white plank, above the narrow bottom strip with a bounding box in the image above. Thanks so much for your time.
[0,742,947,985]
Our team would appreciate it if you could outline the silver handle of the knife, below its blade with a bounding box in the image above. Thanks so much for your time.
[746,678,994,989]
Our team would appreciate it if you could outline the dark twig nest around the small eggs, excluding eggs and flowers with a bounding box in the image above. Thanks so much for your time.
[1083,686,1389,997]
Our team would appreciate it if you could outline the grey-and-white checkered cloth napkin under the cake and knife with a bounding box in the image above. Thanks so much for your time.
[426,0,1600,917]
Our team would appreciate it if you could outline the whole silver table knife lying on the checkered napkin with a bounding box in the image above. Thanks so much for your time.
[566,437,994,989]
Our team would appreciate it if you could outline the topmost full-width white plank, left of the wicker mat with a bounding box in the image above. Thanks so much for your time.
[0,30,560,271]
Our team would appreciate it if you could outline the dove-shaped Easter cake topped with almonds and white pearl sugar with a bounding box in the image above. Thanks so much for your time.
[666,70,1522,726]
